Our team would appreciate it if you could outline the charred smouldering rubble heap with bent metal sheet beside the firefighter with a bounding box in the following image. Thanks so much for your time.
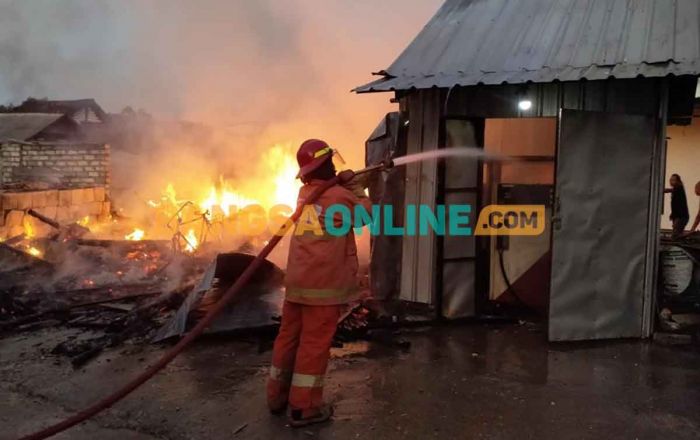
[0,205,382,368]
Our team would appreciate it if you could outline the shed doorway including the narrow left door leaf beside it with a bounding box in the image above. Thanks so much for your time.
[437,118,557,319]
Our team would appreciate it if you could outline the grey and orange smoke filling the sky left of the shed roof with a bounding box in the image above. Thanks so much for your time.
[0,0,441,165]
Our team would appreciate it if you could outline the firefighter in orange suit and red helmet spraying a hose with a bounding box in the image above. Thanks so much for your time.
[267,139,370,427]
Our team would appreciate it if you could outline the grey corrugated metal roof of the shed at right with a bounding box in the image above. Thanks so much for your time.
[355,0,700,92]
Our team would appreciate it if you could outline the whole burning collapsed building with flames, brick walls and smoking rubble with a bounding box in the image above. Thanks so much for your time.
[0,92,306,365]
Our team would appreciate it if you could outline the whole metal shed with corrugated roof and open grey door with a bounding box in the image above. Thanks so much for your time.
[356,0,700,340]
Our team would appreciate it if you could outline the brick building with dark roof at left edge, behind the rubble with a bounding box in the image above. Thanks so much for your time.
[0,99,110,239]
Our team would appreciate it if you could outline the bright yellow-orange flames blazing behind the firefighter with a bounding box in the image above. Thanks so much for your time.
[10,145,301,257]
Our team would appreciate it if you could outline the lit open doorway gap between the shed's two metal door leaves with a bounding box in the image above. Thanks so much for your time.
[483,118,557,317]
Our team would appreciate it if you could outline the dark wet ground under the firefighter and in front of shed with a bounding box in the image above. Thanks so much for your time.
[0,325,700,440]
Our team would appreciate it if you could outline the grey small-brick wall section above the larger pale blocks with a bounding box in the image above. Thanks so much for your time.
[0,142,110,188]
